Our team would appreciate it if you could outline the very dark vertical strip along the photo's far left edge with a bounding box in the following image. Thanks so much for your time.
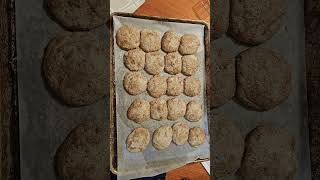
[0,0,20,180]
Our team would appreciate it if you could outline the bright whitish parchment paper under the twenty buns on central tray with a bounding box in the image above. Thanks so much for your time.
[113,16,209,178]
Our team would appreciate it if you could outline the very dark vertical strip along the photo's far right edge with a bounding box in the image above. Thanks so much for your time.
[305,0,320,179]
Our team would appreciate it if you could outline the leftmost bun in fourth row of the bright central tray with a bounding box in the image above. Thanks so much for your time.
[127,99,150,124]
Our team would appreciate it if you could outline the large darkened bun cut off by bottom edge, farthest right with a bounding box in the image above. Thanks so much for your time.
[240,126,297,180]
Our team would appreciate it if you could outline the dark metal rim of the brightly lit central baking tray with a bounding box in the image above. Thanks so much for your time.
[109,12,211,175]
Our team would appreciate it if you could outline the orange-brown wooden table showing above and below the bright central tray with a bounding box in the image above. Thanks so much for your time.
[134,0,210,180]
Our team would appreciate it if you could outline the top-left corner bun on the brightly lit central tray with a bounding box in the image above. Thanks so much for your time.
[116,25,140,50]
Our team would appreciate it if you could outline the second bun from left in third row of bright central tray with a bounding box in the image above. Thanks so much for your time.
[148,75,167,98]
